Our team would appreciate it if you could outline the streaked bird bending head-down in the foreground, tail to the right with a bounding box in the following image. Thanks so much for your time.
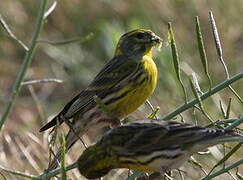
[78,119,243,179]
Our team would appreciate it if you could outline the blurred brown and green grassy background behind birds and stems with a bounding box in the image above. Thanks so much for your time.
[0,0,243,179]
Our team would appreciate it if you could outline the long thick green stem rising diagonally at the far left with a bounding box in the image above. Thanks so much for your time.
[0,0,47,130]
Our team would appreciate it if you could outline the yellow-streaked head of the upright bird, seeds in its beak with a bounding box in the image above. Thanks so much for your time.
[115,29,162,56]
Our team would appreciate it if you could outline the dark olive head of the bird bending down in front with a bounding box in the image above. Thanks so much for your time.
[78,143,114,179]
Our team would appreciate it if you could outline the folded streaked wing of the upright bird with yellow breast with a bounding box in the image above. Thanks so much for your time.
[40,55,138,132]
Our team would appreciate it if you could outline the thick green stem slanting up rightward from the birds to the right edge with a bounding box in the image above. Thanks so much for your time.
[162,73,243,120]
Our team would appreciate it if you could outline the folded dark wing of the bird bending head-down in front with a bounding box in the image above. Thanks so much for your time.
[110,120,223,156]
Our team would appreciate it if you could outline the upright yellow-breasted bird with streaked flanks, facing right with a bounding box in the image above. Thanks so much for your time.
[40,29,162,170]
